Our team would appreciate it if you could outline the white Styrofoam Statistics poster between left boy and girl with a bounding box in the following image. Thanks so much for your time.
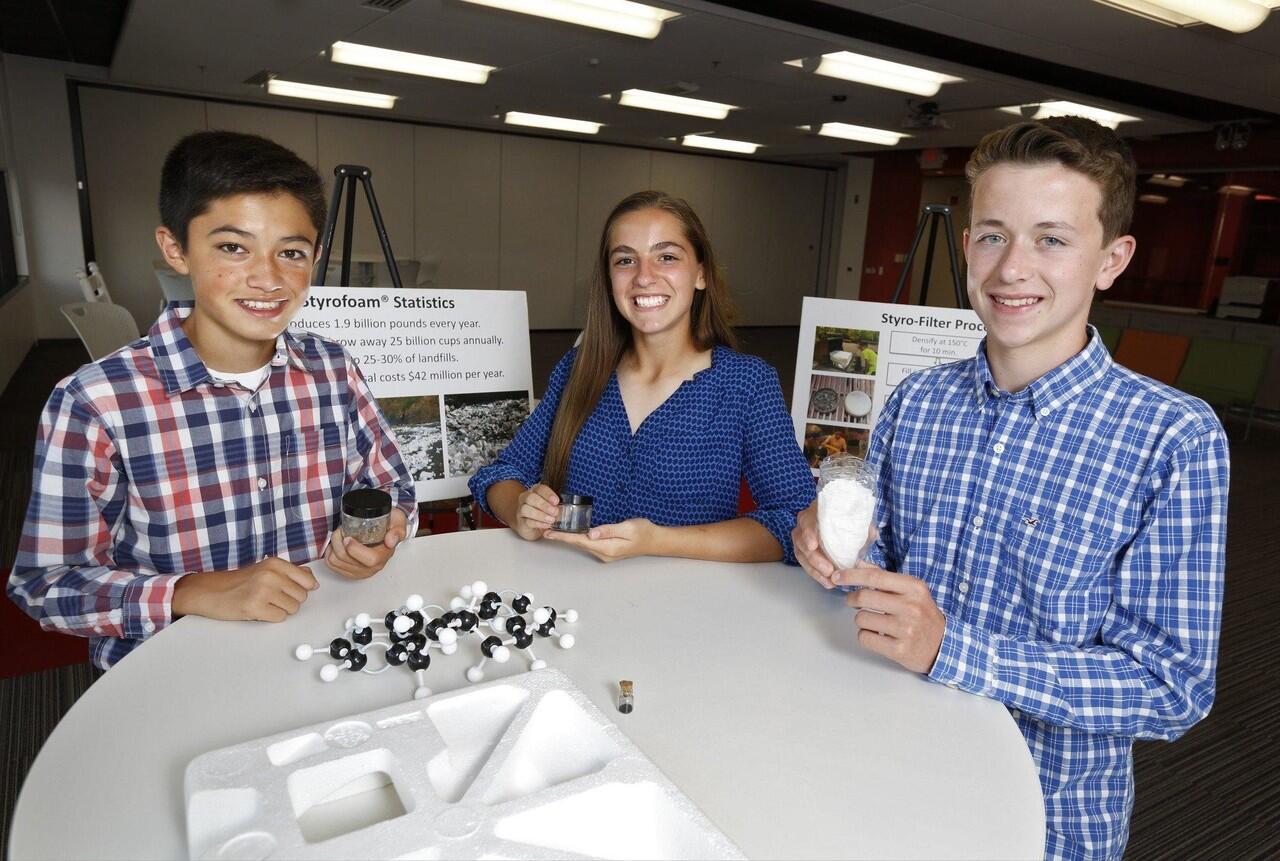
[291,287,532,502]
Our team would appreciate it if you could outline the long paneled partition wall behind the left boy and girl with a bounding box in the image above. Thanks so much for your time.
[81,87,835,329]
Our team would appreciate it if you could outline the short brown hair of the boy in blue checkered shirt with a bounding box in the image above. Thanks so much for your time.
[964,116,1138,243]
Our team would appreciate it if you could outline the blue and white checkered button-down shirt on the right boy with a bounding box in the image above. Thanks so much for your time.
[868,329,1228,858]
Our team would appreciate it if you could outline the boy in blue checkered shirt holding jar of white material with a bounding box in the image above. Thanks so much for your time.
[794,116,1228,858]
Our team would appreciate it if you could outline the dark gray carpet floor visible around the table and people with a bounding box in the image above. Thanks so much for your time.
[0,330,1280,861]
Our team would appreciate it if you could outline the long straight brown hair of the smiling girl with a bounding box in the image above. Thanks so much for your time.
[543,191,737,493]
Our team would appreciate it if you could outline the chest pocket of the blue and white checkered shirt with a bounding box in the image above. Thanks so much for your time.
[1000,513,1115,646]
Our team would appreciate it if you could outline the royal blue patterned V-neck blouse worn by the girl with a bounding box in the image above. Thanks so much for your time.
[470,347,814,564]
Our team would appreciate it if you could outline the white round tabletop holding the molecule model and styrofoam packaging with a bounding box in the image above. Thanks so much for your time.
[9,530,1044,861]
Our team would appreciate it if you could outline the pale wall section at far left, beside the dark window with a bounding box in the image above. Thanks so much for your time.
[0,54,106,338]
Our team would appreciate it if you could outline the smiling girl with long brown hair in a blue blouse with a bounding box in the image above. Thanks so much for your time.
[470,191,814,563]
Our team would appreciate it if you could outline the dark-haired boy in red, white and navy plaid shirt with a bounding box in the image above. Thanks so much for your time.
[8,132,417,668]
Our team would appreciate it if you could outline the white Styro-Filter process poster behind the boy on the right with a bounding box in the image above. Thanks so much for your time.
[791,297,986,470]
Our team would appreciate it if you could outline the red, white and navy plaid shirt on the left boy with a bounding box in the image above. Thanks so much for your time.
[9,303,417,668]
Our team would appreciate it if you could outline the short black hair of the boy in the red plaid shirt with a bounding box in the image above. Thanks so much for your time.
[160,132,326,247]
